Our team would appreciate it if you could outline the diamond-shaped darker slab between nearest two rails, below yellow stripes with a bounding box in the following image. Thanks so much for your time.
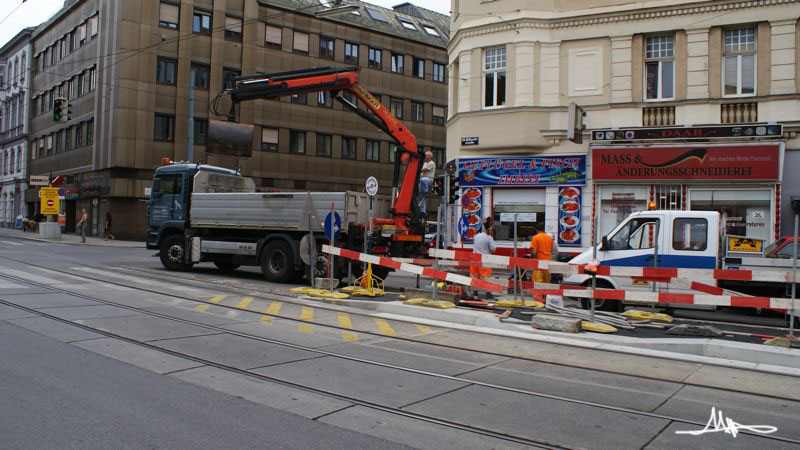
[153,334,320,369]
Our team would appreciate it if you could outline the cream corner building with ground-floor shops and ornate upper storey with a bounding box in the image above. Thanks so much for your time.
[447,0,800,251]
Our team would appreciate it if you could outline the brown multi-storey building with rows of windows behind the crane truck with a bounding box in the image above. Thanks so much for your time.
[28,0,449,239]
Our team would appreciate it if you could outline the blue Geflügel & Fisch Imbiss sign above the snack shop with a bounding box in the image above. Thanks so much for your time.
[458,155,586,187]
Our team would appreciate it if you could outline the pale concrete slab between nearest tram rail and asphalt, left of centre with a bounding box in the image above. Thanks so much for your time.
[170,367,350,419]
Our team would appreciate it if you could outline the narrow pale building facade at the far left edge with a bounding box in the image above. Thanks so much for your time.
[0,28,33,228]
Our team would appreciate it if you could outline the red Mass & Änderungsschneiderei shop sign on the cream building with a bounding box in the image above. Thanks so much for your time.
[592,144,781,180]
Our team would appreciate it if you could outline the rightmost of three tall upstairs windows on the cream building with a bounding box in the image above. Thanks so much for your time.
[722,28,756,96]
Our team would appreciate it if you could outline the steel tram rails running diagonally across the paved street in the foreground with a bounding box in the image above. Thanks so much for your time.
[0,257,800,448]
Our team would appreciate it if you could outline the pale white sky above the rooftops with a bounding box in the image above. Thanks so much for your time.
[0,0,450,46]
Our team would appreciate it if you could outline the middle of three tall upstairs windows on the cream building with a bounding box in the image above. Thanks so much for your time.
[644,36,675,100]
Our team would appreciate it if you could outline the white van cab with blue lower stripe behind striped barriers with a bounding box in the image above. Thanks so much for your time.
[563,210,720,309]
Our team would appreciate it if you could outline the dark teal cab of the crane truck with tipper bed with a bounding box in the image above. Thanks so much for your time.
[145,163,241,249]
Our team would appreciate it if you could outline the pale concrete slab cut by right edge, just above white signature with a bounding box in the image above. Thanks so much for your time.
[684,366,800,401]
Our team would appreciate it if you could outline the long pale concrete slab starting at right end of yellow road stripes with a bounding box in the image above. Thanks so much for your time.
[414,331,700,381]
